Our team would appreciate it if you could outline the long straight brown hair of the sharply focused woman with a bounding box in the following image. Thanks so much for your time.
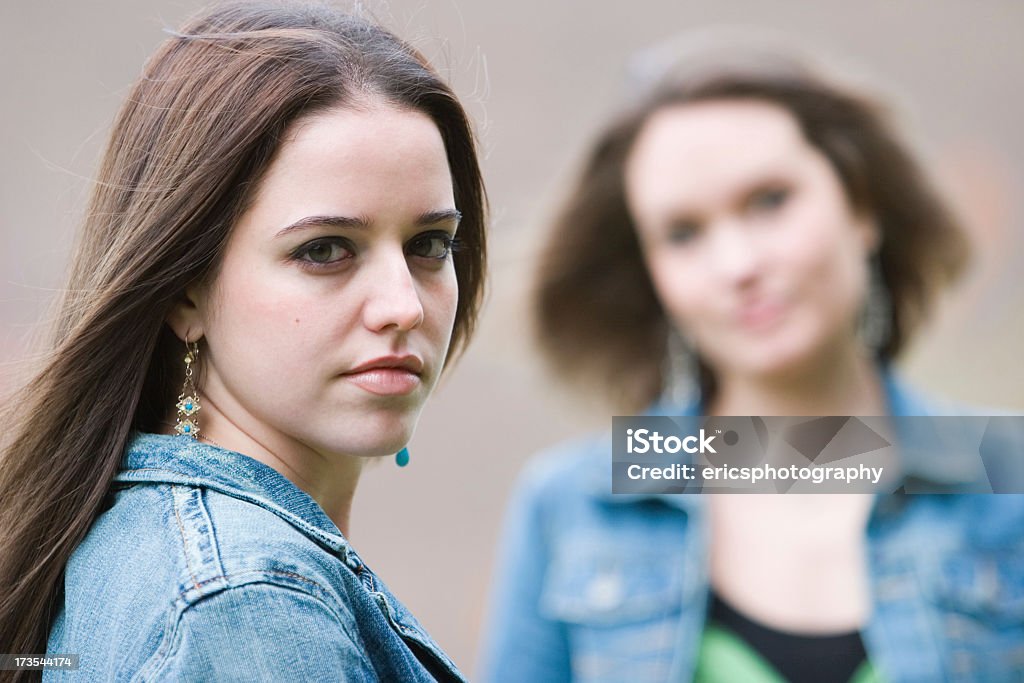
[0,2,486,680]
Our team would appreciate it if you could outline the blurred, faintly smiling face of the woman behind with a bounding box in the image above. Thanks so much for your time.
[625,100,877,376]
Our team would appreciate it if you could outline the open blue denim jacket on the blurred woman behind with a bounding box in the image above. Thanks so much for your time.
[481,373,1024,683]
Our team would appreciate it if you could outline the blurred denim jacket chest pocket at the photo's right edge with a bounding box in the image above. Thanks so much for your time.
[930,547,1024,681]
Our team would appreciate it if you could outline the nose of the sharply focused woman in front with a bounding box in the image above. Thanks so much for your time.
[364,253,423,332]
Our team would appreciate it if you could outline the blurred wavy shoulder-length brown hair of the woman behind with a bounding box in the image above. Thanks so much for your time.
[534,46,968,412]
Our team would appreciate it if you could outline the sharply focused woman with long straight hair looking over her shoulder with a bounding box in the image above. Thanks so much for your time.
[0,2,485,681]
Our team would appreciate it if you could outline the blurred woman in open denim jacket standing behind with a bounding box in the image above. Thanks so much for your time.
[483,34,1024,683]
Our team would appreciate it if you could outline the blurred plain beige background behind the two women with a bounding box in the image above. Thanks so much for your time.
[0,0,1024,674]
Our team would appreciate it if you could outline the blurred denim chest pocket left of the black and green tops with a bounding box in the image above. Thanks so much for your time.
[540,544,695,683]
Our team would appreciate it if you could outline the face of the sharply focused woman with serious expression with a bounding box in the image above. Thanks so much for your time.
[186,104,459,456]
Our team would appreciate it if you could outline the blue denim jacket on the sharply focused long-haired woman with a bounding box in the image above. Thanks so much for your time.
[44,434,464,683]
